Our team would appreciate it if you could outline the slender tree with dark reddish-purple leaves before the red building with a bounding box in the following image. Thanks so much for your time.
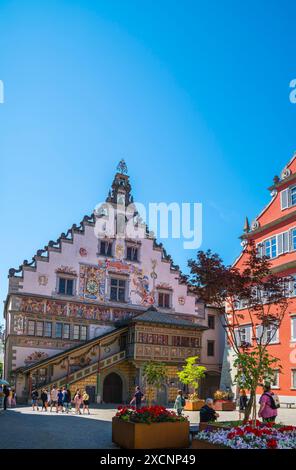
[188,240,291,419]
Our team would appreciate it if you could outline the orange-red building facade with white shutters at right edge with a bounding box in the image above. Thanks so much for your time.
[222,155,296,402]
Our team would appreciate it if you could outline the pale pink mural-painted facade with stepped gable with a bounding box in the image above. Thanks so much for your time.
[4,163,223,399]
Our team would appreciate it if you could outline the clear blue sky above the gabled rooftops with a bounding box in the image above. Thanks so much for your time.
[0,0,296,324]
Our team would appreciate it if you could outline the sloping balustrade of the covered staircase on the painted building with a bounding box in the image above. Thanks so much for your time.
[37,351,126,395]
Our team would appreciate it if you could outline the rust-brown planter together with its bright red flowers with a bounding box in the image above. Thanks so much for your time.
[112,406,189,449]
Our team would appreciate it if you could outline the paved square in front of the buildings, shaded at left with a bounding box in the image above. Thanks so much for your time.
[0,406,296,449]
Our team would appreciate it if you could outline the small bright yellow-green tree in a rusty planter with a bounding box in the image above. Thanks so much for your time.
[177,356,207,411]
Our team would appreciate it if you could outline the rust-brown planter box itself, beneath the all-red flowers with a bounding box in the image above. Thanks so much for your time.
[112,417,189,449]
